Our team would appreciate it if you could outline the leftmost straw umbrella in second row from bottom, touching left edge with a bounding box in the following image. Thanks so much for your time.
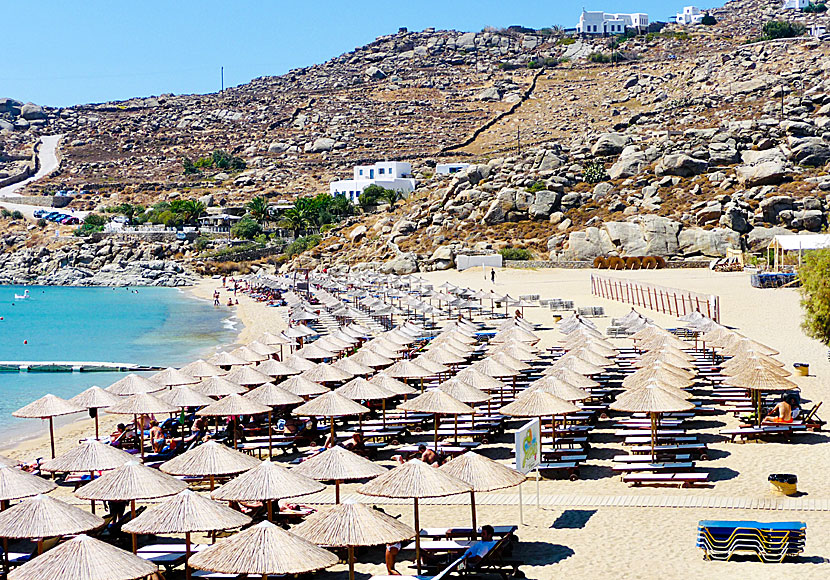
[0,495,104,554]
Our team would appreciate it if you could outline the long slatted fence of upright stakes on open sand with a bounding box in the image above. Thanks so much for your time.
[591,274,720,322]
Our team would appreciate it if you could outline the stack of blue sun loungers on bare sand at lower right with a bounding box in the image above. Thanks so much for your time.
[697,520,807,562]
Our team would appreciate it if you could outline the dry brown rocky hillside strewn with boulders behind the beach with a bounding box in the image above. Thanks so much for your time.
[0,0,830,271]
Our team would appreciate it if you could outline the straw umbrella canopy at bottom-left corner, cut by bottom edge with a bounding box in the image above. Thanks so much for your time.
[9,534,158,580]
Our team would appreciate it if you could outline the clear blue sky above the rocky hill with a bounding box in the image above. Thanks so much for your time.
[0,0,717,106]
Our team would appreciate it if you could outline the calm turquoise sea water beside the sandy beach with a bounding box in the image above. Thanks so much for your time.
[0,286,236,443]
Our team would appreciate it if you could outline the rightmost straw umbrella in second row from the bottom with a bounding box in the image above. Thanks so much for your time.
[291,503,416,580]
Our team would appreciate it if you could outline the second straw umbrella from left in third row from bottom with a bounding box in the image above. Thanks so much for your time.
[75,460,187,554]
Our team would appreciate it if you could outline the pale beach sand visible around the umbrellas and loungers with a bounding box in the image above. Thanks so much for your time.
[4,268,830,580]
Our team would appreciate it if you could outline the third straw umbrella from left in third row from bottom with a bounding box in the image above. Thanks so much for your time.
[210,461,326,522]
